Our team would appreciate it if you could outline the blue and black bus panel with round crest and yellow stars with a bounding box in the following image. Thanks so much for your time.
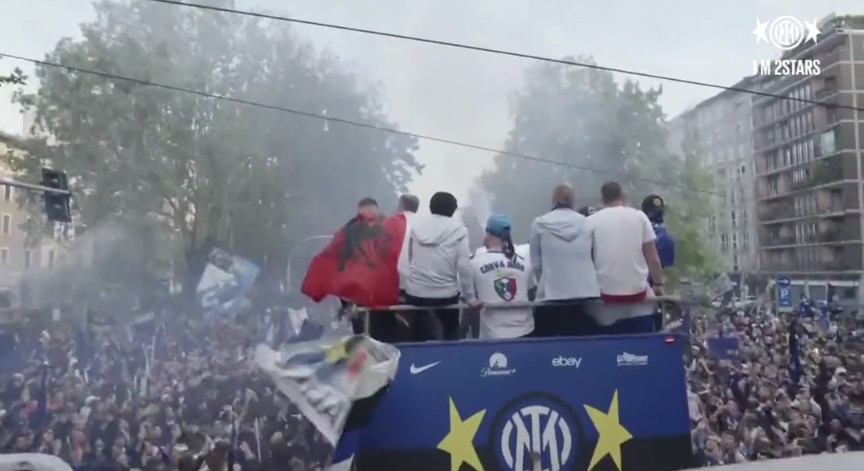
[343,296,694,471]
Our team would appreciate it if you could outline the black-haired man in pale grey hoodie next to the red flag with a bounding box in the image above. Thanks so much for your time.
[405,192,475,341]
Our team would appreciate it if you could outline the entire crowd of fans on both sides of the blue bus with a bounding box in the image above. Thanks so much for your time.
[0,296,864,471]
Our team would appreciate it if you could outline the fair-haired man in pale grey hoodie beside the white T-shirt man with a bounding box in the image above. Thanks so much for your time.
[529,185,600,337]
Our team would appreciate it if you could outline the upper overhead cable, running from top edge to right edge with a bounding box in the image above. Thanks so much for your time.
[147,0,864,111]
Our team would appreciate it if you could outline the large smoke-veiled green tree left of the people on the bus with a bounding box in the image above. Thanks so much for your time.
[9,0,421,296]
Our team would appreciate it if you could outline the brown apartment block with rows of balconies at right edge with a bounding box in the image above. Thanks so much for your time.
[753,17,864,300]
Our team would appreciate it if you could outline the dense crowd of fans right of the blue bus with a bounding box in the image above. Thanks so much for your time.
[688,305,864,466]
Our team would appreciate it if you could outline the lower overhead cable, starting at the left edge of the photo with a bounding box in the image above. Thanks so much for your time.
[0,52,718,195]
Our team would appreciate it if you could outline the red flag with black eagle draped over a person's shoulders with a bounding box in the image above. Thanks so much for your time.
[301,214,408,307]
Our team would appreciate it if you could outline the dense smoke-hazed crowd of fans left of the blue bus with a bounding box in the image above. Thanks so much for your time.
[0,310,332,471]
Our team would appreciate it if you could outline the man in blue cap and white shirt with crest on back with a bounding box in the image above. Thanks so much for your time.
[471,214,534,339]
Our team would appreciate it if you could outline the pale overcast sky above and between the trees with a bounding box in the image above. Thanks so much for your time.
[0,0,864,206]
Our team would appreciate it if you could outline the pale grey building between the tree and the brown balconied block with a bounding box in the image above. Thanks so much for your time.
[669,78,759,276]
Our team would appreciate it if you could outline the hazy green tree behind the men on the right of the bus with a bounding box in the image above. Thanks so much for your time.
[479,58,714,286]
